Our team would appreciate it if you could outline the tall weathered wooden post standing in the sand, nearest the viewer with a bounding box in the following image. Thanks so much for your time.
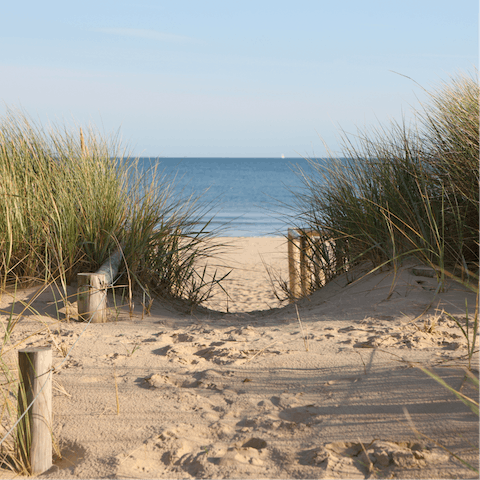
[17,347,52,475]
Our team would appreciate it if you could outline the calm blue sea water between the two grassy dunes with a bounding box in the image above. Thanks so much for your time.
[140,158,318,237]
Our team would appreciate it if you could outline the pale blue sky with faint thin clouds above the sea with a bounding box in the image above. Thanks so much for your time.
[0,0,480,158]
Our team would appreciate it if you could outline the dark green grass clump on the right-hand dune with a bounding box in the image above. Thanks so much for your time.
[296,70,480,286]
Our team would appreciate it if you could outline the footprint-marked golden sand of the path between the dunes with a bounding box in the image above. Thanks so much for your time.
[0,238,479,480]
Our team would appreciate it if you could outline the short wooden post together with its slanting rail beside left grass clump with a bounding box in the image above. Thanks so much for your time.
[77,251,122,323]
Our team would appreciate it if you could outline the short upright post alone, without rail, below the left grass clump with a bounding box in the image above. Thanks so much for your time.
[77,273,107,323]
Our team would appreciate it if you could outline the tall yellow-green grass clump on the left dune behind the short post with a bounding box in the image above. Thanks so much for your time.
[0,110,225,304]
